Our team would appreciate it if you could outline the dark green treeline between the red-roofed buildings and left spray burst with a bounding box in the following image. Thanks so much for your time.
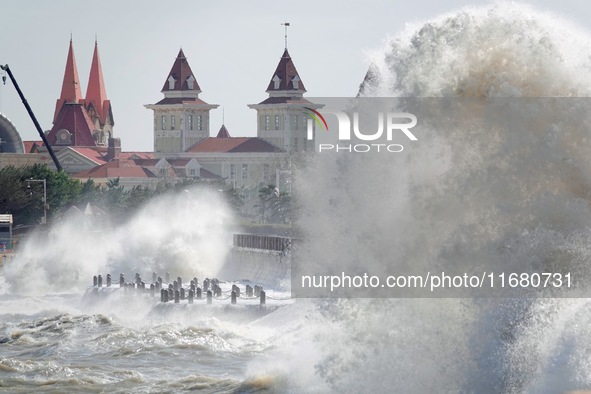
[0,164,244,225]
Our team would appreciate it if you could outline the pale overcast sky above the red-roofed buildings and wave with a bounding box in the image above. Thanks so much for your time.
[0,0,591,151]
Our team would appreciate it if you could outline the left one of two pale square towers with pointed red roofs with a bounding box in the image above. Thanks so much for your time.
[145,49,218,157]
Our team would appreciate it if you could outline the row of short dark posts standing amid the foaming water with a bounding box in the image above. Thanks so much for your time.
[92,272,266,305]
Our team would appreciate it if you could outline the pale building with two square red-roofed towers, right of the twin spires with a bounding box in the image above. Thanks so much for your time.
[145,44,318,190]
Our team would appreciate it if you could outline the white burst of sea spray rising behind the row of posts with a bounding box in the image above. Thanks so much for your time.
[5,189,233,294]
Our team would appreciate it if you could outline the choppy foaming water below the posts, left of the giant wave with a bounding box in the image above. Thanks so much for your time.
[0,277,310,393]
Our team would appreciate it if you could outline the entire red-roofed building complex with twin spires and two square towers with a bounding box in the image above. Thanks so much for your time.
[2,40,319,202]
